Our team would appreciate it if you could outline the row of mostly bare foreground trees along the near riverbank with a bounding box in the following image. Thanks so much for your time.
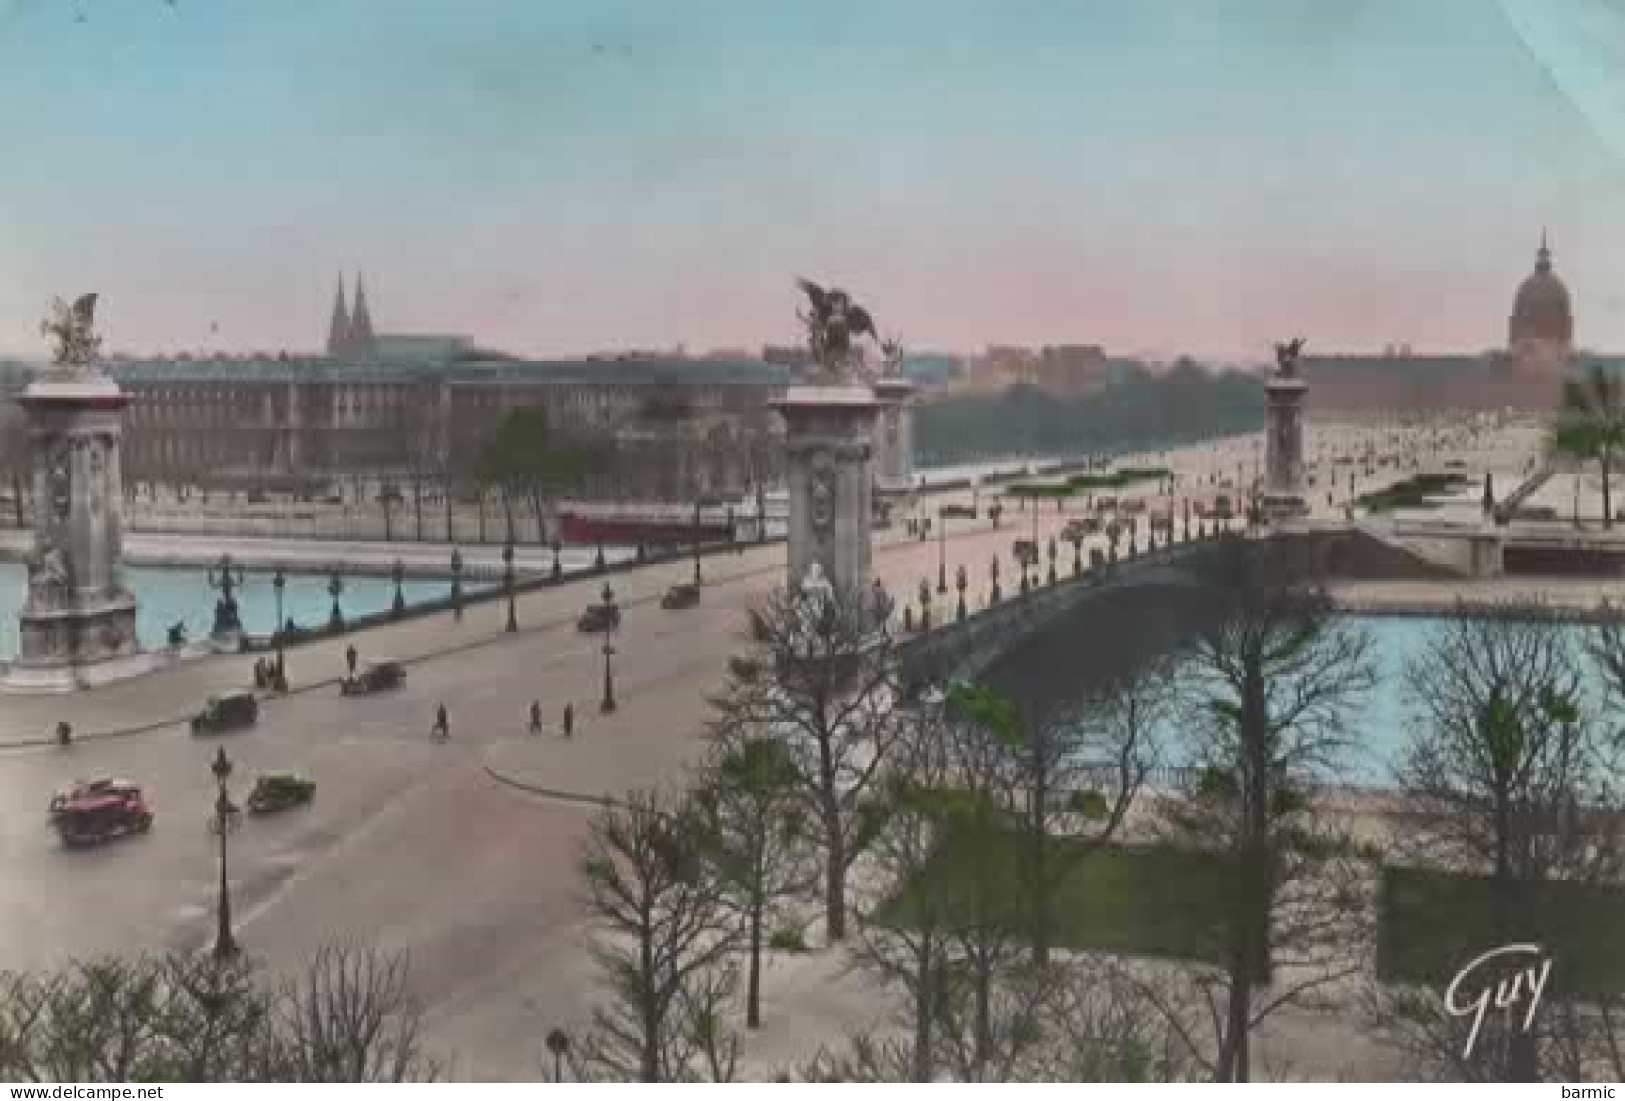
[575,541,1625,1082]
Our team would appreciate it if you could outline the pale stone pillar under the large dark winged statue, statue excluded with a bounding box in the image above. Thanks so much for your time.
[775,385,879,599]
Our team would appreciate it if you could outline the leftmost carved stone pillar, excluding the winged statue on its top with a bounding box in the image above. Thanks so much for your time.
[0,375,154,692]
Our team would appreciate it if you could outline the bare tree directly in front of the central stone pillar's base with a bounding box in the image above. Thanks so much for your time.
[713,589,899,940]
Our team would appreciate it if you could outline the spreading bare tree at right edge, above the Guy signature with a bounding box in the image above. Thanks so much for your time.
[1372,604,1625,1082]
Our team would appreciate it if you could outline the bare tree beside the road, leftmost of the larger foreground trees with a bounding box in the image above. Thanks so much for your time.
[582,791,735,1082]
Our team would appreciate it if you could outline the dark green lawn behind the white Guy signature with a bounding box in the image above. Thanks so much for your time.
[1376,867,1625,995]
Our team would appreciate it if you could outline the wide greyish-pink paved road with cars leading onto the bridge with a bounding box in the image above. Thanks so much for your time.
[0,422,1534,1078]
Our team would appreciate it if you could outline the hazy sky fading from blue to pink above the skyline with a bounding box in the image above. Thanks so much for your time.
[0,0,1625,359]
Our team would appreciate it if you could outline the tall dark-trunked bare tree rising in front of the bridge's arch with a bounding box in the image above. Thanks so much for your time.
[1168,541,1375,1082]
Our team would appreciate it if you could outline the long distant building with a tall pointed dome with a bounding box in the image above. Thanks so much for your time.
[1303,232,1625,419]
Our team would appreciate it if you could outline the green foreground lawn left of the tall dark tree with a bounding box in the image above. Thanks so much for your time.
[878,833,1230,963]
